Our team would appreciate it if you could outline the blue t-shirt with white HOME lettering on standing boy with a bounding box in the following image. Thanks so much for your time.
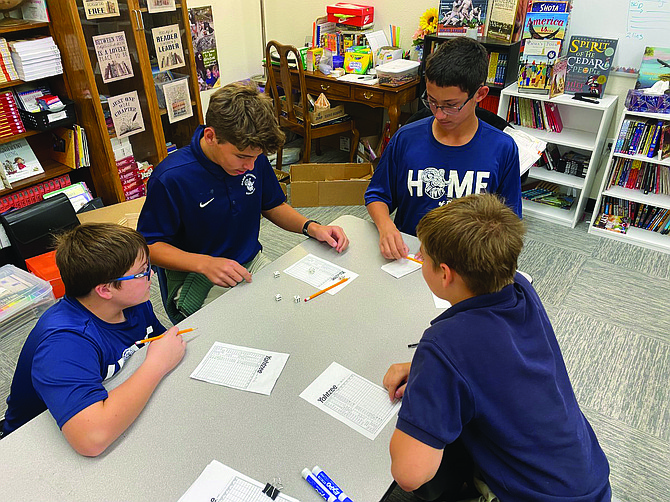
[365,117,521,235]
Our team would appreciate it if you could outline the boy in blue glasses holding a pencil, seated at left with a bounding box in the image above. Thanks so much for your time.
[0,223,186,456]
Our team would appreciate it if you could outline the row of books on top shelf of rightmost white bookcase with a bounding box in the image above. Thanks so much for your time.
[614,119,670,159]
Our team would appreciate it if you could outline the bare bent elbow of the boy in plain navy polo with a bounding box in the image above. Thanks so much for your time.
[389,429,443,492]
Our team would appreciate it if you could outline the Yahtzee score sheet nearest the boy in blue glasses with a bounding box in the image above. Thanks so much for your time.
[191,342,288,396]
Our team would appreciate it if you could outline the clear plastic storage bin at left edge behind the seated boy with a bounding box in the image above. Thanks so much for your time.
[0,265,56,338]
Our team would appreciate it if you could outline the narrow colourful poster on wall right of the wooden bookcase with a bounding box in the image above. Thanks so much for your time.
[188,6,220,91]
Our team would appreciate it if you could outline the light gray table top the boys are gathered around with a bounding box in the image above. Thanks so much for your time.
[0,216,441,502]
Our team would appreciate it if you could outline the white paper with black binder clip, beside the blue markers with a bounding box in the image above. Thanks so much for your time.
[179,460,298,502]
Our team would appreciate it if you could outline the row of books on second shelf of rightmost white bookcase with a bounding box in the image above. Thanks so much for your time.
[609,157,670,195]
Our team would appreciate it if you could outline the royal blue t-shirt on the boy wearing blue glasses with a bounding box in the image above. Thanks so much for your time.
[3,296,165,434]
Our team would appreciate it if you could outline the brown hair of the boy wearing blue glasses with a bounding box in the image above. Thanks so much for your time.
[56,223,149,298]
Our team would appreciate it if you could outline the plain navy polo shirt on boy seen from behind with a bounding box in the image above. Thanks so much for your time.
[397,274,611,502]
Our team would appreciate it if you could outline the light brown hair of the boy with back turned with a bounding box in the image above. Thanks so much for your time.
[416,193,526,295]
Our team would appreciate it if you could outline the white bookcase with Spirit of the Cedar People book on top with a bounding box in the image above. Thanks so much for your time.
[498,83,618,227]
